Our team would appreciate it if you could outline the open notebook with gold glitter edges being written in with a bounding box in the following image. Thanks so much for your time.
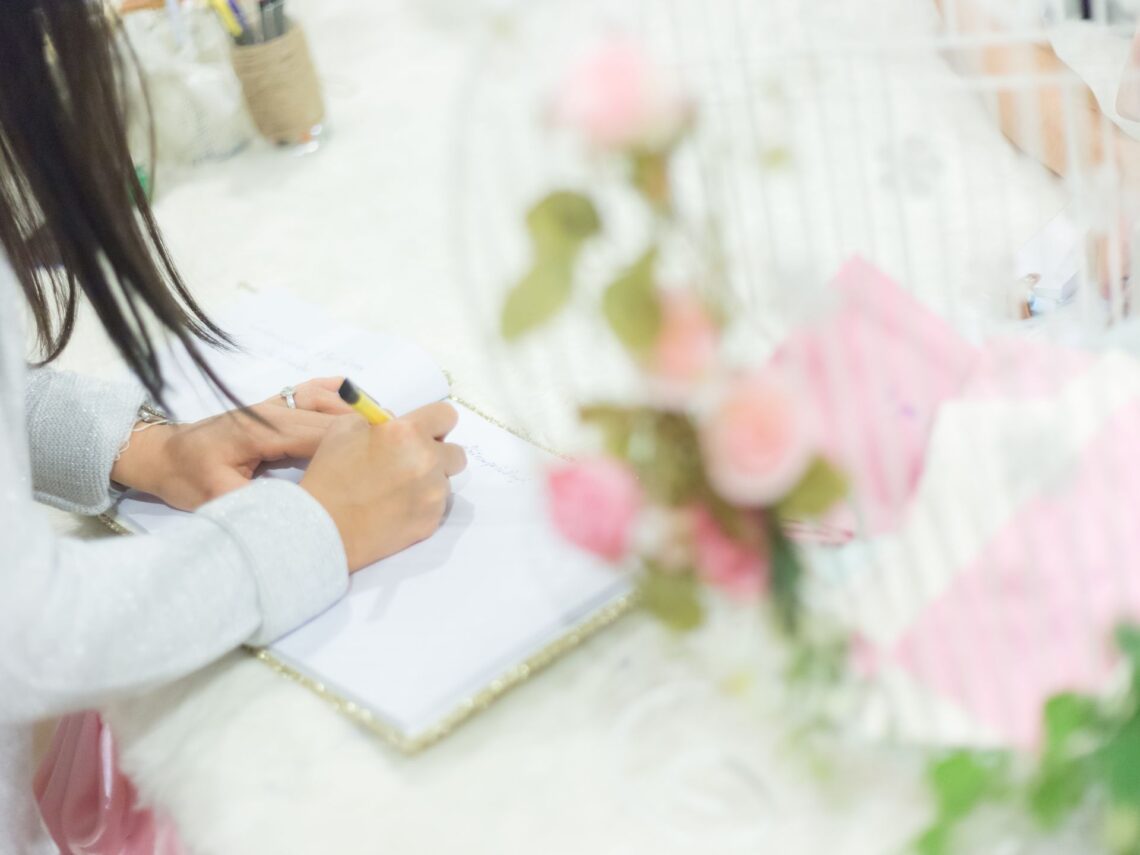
[111,293,632,750]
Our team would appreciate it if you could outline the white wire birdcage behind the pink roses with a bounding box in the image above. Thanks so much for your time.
[454,0,1140,807]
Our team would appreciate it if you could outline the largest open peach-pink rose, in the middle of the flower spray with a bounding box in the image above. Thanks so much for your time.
[701,367,815,507]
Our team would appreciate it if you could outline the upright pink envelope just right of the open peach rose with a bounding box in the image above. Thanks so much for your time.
[774,258,979,536]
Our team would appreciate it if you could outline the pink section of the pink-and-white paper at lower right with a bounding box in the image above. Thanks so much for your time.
[863,401,1140,747]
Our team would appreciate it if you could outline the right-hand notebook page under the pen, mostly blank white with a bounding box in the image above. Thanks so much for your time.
[270,406,629,735]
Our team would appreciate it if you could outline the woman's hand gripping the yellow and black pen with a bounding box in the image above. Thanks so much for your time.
[301,404,467,572]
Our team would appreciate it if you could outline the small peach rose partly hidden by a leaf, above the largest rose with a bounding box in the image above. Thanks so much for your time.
[646,291,719,404]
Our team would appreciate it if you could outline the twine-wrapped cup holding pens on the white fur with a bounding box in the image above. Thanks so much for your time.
[231,22,325,148]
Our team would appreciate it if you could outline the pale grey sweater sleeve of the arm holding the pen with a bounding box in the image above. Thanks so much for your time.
[0,476,348,720]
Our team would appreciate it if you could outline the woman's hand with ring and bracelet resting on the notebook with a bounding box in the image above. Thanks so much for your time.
[111,377,352,511]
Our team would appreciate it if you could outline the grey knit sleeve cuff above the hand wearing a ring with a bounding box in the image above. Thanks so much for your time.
[24,368,145,515]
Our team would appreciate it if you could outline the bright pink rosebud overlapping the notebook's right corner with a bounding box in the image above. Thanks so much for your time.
[547,457,642,561]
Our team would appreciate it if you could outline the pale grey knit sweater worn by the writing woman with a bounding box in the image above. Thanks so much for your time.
[0,253,348,855]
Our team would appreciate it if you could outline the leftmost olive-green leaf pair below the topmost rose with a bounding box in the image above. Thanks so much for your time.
[499,190,602,341]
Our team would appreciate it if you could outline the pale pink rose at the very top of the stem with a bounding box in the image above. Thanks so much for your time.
[554,39,691,150]
